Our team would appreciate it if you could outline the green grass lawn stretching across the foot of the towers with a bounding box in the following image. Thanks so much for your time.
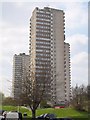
[0,106,88,120]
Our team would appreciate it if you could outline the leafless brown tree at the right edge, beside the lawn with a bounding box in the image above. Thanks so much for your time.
[72,85,88,110]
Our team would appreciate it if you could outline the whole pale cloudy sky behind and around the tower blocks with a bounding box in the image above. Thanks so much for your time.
[0,0,88,96]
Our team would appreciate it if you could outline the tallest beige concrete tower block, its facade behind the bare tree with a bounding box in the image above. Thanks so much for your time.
[29,7,70,104]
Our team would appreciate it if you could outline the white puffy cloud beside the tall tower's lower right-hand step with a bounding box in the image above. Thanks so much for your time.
[66,34,88,55]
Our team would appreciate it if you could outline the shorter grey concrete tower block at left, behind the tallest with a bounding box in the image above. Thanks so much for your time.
[12,53,29,99]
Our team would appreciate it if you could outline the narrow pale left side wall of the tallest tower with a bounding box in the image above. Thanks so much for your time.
[30,10,36,73]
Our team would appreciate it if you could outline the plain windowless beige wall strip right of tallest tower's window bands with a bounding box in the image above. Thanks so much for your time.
[52,10,65,103]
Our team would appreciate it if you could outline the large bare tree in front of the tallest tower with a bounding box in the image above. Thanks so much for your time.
[20,62,50,118]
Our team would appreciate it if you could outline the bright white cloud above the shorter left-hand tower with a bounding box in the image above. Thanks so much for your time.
[0,23,29,53]
